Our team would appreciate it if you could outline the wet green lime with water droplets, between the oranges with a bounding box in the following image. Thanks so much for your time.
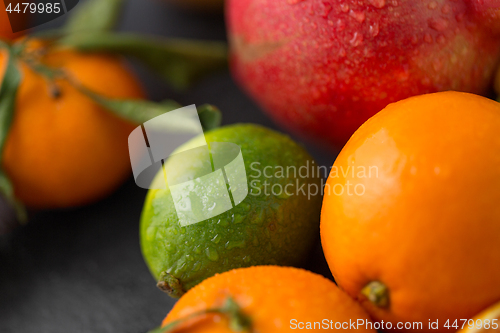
[141,124,321,297]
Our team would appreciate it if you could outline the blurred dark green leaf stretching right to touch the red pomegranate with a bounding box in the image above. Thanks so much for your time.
[61,33,227,89]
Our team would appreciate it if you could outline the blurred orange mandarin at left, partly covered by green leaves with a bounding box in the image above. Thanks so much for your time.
[0,42,144,208]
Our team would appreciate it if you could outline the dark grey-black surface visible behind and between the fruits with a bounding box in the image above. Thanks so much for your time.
[0,0,336,333]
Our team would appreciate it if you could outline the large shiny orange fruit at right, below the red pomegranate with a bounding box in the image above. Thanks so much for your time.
[321,92,500,332]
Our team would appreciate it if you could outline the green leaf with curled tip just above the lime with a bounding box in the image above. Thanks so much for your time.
[78,86,221,131]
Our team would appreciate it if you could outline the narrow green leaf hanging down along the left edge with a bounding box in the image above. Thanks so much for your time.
[0,43,26,222]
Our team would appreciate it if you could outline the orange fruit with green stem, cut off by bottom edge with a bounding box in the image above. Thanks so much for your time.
[163,266,375,333]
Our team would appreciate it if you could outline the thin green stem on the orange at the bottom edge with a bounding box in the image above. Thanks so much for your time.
[149,297,252,333]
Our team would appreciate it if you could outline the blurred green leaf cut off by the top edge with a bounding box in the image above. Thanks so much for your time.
[63,0,124,34]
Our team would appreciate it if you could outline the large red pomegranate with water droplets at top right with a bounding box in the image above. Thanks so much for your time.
[226,0,500,148]
